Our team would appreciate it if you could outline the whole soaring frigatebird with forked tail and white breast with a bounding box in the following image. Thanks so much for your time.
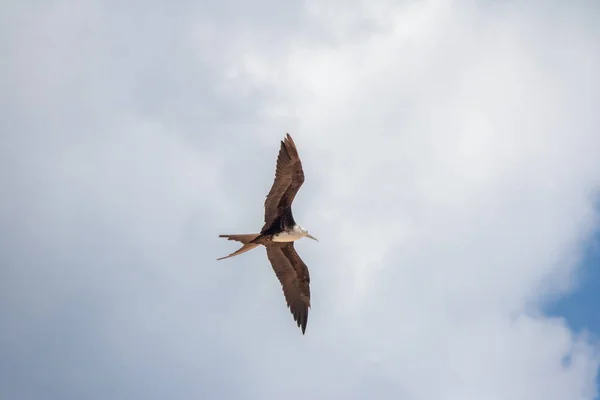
[217,133,318,335]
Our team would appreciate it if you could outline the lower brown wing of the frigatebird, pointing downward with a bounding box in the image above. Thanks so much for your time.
[266,242,310,335]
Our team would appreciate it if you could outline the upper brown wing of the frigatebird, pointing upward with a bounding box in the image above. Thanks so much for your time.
[262,133,304,232]
